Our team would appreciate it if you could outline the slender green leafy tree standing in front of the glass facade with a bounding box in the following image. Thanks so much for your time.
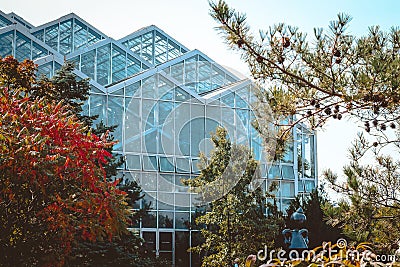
[186,128,282,266]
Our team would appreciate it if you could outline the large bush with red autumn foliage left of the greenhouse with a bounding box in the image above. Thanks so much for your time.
[0,58,127,266]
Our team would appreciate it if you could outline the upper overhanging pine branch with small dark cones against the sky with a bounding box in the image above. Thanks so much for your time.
[210,0,400,155]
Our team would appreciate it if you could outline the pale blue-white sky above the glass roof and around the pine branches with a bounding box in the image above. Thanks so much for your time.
[0,0,400,182]
